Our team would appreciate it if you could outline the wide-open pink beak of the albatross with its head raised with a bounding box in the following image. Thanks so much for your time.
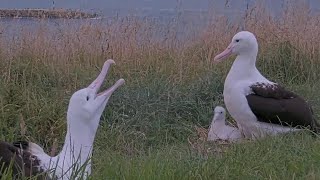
[88,59,125,98]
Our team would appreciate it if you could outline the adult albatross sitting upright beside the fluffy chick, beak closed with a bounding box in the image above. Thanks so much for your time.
[214,31,320,138]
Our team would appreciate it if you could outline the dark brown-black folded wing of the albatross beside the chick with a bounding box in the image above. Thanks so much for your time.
[246,83,318,129]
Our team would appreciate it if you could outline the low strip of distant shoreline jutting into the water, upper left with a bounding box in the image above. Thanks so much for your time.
[0,9,98,19]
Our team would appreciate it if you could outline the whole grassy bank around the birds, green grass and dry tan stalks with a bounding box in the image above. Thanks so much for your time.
[0,0,320,179]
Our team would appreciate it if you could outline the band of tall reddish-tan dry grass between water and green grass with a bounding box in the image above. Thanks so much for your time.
[0,1,320,84]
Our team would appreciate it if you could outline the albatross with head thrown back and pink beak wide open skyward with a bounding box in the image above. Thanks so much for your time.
[0,59,125,179]
